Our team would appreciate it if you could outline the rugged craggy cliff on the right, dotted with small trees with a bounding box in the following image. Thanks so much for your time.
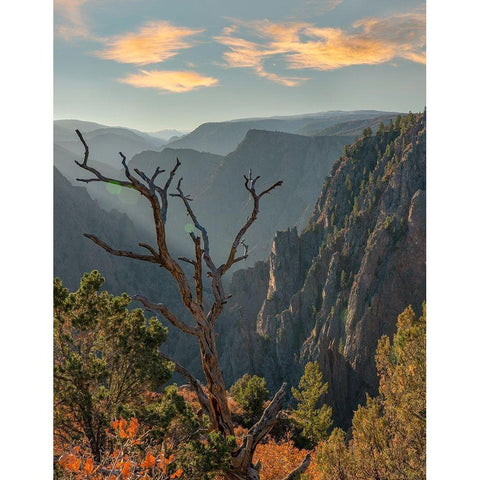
[219,114,426,426]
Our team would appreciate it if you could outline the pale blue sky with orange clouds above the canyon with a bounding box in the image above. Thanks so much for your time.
[54,0,426,132]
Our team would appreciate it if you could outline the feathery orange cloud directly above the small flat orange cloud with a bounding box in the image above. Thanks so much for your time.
[95,21,203,65]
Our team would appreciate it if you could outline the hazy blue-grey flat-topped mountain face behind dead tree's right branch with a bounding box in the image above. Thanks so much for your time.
[195,130,354,262]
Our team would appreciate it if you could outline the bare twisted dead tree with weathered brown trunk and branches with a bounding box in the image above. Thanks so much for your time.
[75,130,310,480]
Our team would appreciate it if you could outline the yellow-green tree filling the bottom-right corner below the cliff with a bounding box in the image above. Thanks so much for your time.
[310,307,426,480]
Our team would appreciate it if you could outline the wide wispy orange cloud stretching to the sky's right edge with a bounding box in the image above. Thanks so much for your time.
[215,11,425,86]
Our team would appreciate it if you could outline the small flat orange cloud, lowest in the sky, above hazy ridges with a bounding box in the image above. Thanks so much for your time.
[119,70,218,93]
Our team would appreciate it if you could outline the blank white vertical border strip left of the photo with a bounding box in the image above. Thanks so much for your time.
[0,0,53,479]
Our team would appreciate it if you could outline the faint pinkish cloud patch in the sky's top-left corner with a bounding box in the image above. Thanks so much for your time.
[54,0,91,40]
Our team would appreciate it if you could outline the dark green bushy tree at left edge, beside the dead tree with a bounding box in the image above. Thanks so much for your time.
[54,270,172,461]
